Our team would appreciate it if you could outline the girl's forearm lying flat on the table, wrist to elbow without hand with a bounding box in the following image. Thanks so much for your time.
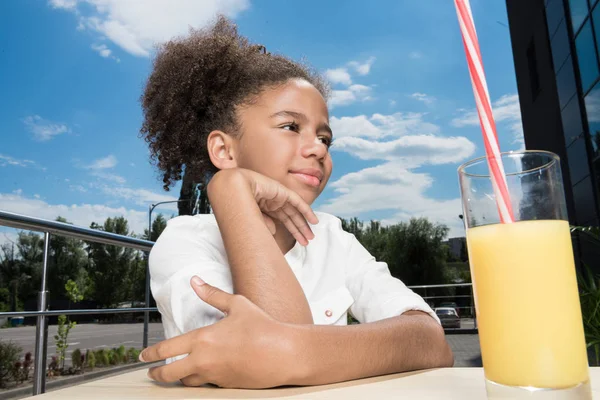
[291,311,454,385]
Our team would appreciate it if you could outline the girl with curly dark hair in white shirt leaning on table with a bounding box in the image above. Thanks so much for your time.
[141,17,453,388]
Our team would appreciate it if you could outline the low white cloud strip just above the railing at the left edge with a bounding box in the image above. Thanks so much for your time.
[0,193,148,234]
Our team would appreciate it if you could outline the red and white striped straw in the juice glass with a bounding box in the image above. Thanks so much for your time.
[454,0,514,224]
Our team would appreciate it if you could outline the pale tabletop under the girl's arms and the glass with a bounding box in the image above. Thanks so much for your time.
[23,368,600,400]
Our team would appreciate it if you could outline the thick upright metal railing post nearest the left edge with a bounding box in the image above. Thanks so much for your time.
[33,232,50,396]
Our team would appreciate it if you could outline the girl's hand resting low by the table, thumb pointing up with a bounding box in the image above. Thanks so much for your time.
[140,277,297,389]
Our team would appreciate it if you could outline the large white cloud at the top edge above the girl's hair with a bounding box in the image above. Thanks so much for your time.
[49,0,250,57]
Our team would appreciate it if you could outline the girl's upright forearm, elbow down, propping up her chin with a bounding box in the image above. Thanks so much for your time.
[208,169,316,324]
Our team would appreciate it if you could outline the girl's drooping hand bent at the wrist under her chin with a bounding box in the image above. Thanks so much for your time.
[208,168,319,246]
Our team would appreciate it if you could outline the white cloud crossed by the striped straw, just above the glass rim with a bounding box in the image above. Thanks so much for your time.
[451,94,525,150]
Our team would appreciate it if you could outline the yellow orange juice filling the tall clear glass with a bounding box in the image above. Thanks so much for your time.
[467,220,589,389]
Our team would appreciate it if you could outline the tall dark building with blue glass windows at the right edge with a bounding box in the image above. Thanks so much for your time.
[506,0,600,271]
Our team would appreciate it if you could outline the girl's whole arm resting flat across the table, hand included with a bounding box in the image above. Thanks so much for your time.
[141,280,453,388]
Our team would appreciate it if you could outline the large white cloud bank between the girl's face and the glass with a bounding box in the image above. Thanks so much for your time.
[318,107,475,236]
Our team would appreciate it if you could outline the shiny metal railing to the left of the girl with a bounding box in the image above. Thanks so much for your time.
[0,211,157,396]
